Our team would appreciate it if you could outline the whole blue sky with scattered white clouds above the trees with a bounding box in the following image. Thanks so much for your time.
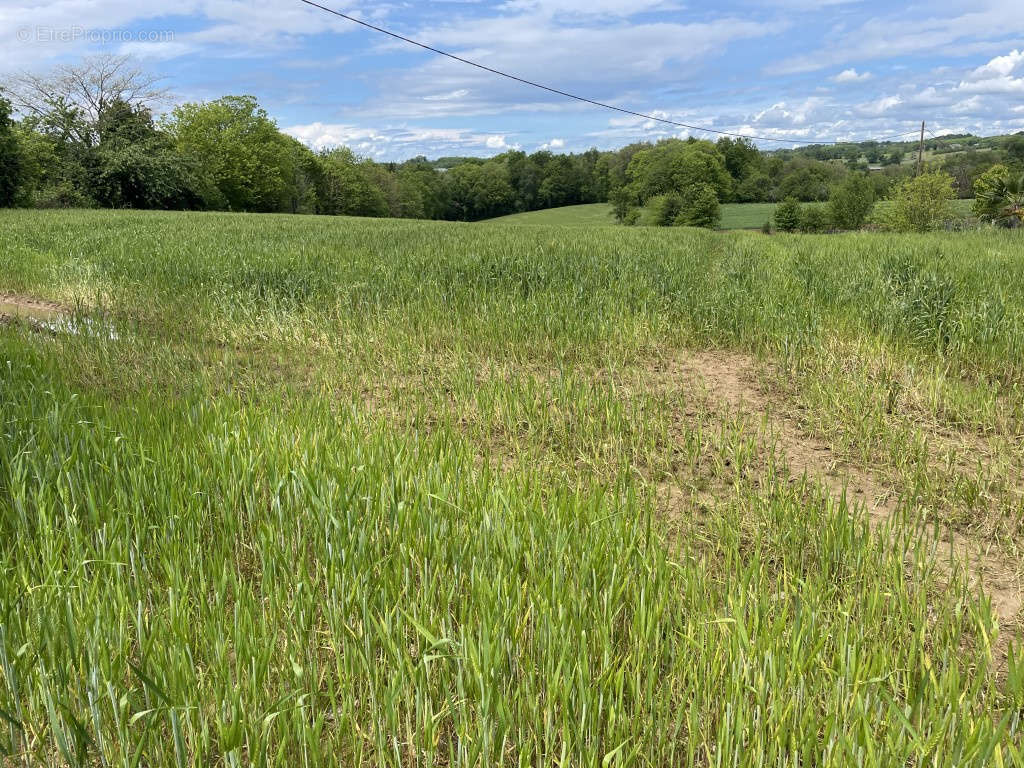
[0,0,1024,160]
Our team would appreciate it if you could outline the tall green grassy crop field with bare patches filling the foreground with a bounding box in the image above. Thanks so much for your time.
[0,211,1024,767]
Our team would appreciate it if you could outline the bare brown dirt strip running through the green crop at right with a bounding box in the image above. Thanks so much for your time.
[668,351,1024,671]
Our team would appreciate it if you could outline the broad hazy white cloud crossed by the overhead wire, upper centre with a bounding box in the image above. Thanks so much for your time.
[366,12,782,119]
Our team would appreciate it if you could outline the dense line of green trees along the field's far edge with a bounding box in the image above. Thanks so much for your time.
[0,56,1024,226]
